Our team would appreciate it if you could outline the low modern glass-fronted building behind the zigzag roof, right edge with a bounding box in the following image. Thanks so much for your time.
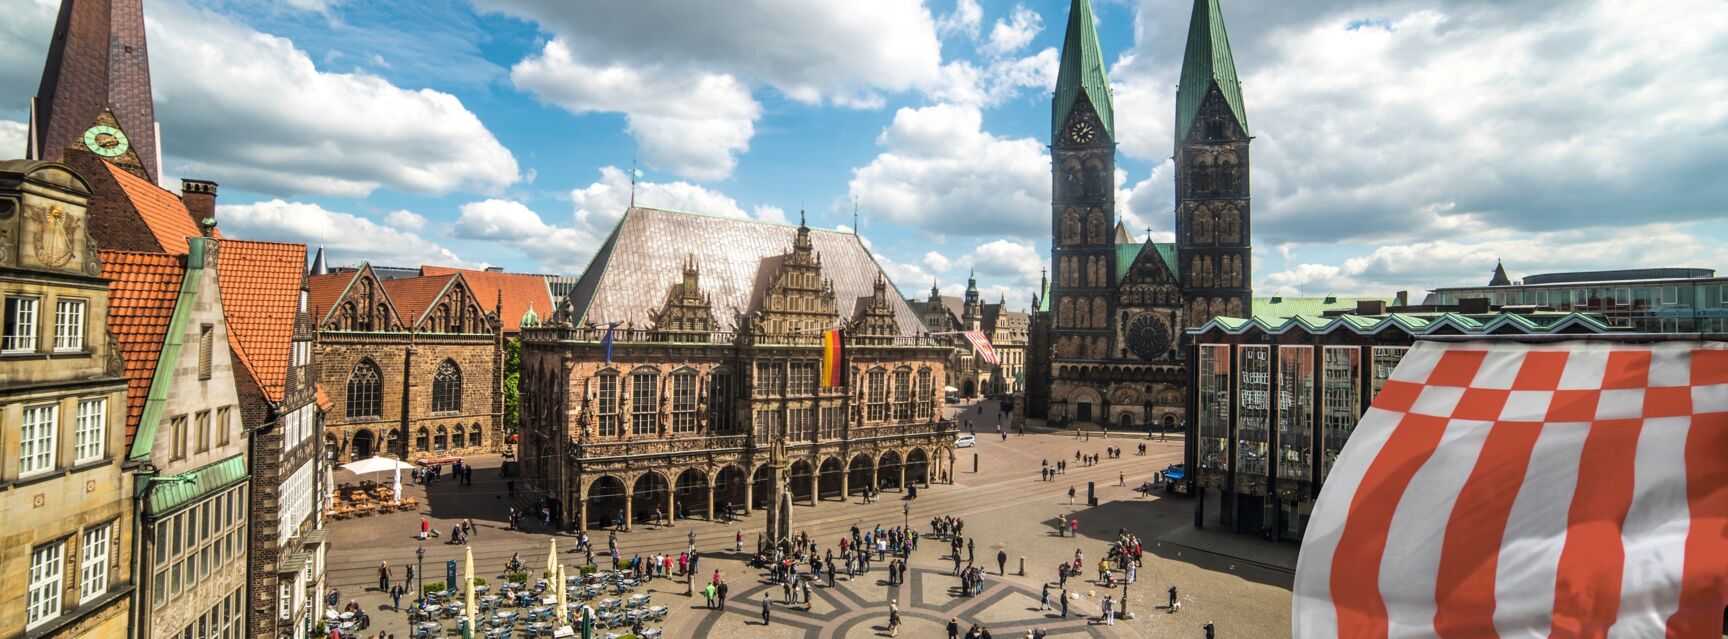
[1424,268,1728,333]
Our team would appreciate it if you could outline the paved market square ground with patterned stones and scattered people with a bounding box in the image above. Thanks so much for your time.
[328,402,1294,637]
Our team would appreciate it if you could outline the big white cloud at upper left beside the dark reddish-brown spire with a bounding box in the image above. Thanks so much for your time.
[149,2,518,197]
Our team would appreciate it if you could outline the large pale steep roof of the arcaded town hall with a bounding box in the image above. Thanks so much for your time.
[570,207,924,335]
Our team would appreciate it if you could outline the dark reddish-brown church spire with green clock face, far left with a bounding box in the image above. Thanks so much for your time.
[26,0,161,181]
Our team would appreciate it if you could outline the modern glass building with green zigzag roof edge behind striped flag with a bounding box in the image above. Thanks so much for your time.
[1187,306,1631,539]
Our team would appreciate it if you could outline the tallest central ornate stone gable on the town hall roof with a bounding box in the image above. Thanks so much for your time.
[752,223,838,335]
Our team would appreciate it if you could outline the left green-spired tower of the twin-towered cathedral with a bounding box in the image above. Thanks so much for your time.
[1049,0,1116,369]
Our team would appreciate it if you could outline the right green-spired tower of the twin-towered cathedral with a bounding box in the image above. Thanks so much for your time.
[1175,0,1253,326]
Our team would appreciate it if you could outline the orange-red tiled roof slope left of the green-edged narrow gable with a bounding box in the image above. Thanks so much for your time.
[100,246,187,447]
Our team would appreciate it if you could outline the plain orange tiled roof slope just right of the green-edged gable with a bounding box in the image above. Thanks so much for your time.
[216,240,306,402]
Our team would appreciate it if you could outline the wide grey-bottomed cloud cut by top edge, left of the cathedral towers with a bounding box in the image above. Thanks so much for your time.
[477,0,942,104]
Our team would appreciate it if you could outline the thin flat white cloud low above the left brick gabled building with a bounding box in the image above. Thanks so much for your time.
[216,199,484,266]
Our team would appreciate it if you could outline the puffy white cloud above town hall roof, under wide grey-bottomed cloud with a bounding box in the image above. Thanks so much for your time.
[510,40,762,180]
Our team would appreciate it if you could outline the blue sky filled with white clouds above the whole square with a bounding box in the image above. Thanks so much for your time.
[0,0,1728,307]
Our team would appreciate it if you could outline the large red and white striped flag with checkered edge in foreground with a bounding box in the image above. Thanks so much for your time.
[1291,342,1728,637]
